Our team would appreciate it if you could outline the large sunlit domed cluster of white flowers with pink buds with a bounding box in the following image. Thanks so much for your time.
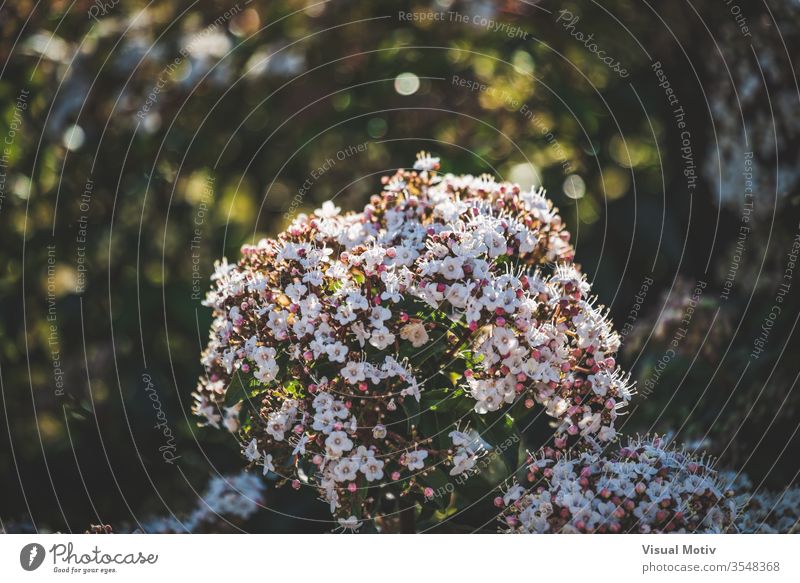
[194,153,632,530]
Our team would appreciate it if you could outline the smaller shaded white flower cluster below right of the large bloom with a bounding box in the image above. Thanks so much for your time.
[495,438,737,533]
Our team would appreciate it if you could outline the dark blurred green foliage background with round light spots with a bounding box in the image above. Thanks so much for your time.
[0,0,800,532]
